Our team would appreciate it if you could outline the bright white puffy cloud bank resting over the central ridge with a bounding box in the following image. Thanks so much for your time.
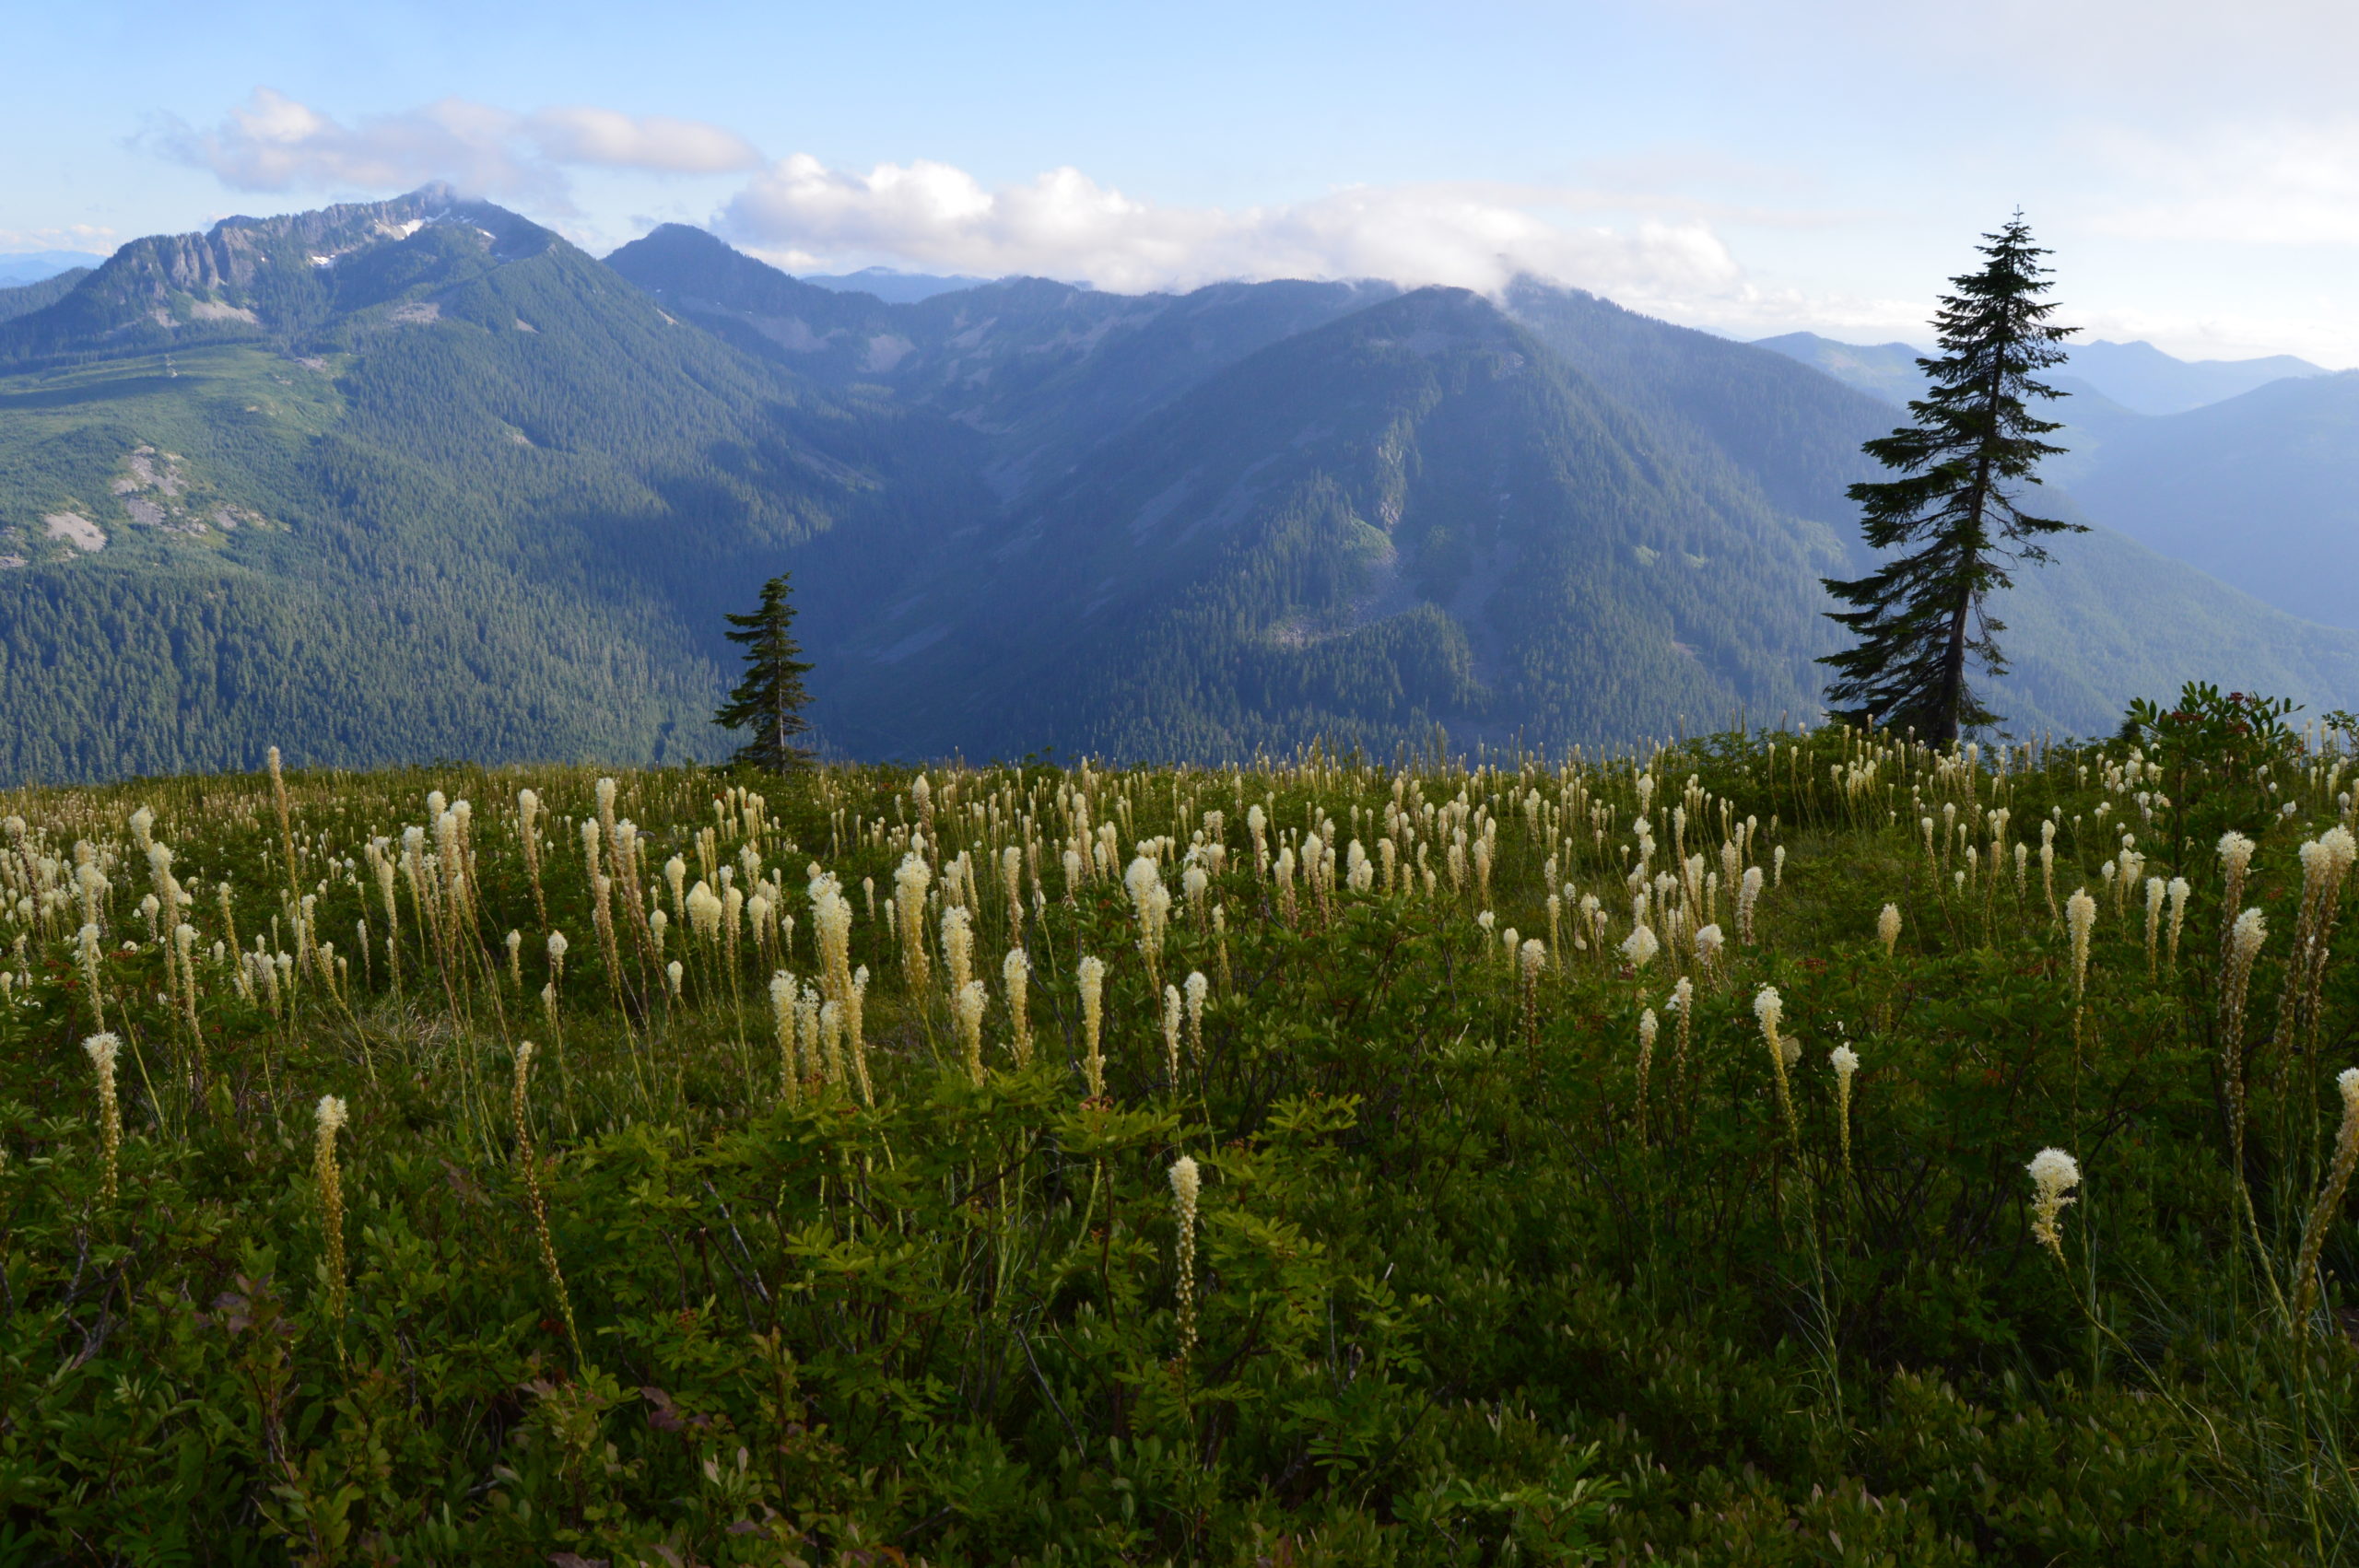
[720,153,1774,307]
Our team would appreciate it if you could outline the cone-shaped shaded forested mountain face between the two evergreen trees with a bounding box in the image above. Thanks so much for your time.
[830,290,1840,757]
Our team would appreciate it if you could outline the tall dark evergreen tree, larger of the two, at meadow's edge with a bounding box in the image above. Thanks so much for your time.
[1819,212,2085,745]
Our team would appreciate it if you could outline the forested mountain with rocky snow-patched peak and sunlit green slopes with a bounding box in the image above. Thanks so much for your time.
[0,191,962,778]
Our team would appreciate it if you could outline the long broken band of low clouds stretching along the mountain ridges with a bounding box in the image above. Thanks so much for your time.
[148,88,1922,334]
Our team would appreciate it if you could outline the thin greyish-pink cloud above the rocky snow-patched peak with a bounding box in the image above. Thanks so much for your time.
[156,88,762,203]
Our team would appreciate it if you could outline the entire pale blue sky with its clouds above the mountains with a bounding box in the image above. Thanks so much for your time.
[0,0,2359,366]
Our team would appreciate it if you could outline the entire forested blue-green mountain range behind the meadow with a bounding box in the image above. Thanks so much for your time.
[0,189,2359,778]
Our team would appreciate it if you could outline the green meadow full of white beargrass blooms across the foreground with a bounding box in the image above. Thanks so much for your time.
[0,693,2359,1568]
